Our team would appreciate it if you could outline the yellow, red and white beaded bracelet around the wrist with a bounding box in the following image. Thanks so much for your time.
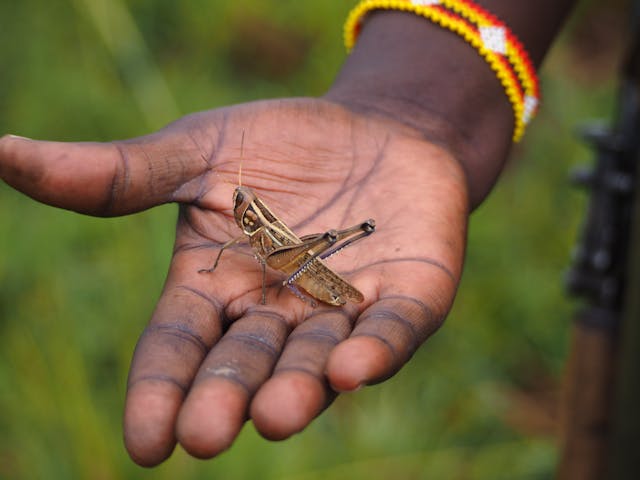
[344,0,540,142]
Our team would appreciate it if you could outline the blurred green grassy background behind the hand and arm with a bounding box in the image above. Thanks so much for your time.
[0,0,624,480]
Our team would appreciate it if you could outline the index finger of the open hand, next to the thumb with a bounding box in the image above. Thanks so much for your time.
[124,286,226,466]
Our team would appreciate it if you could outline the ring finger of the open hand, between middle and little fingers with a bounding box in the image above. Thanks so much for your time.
[250,309,351,440]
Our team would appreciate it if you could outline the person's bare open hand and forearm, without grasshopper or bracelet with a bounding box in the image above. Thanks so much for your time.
[0,0,572,466]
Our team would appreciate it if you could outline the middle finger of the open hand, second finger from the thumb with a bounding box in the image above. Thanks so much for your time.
[176,308,290,458]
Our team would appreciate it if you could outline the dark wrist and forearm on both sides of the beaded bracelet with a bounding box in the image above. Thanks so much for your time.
[327,0,574,207]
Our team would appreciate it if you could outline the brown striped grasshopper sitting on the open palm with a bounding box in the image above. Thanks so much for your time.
[199,163,375,306]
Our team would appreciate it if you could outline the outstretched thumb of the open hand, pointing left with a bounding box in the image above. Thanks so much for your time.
[0,132,213,216]
